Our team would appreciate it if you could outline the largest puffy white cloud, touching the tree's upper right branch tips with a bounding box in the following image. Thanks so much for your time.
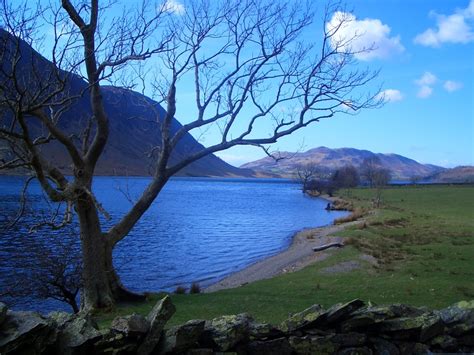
[326,11,405,61]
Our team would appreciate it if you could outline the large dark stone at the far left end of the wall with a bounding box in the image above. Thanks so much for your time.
[0,311,56,354]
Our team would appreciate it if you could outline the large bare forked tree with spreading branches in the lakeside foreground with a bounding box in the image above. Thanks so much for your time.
[0,0,380,310]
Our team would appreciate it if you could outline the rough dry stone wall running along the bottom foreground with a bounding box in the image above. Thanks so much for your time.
[0,297,474,355]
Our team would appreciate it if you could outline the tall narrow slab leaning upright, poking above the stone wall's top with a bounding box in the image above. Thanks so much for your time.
[137,296,176,355]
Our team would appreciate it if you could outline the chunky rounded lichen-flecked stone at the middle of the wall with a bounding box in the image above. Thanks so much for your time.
[201,313,253,351]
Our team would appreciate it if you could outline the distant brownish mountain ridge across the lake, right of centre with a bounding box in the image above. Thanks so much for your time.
[241,147,444,180]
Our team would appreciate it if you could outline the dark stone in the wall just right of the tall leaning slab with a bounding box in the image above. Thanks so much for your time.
[158,320,205,354]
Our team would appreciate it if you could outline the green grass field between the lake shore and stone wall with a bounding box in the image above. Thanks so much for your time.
[94,186,474,325]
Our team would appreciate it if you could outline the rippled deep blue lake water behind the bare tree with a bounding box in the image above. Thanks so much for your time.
[0,176,345,311]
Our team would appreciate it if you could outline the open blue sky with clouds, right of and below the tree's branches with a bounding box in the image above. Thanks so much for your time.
[218,0,474,167]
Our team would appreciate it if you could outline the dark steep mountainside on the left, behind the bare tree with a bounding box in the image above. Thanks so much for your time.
[0,29,255,177]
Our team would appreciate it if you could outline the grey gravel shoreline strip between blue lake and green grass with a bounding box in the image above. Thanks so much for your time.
[203,199,360,293]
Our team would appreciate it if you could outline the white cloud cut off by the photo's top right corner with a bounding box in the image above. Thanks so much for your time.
[414,0,474,47]
